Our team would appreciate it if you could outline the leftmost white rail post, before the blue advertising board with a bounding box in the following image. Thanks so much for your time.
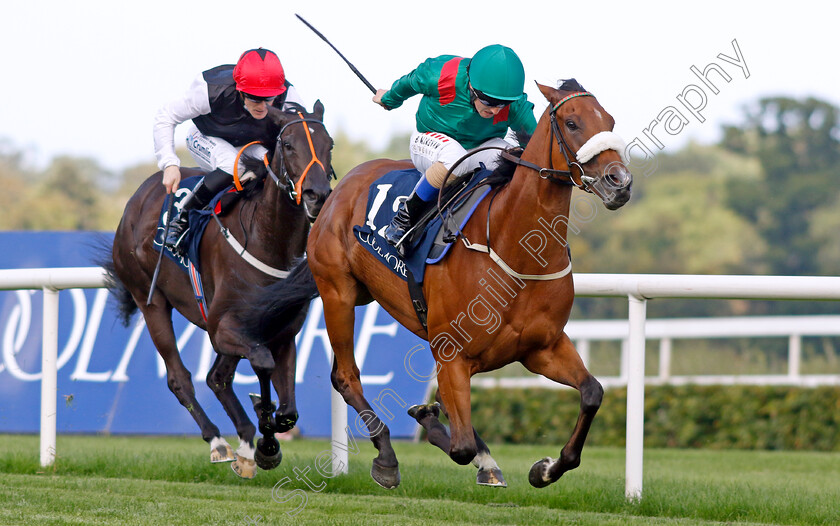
[41,287,58,467]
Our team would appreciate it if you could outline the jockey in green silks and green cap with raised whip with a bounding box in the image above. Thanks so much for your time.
[373,44,537,255]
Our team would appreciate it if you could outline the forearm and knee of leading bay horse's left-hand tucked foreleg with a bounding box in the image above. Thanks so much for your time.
[430,357,476,465]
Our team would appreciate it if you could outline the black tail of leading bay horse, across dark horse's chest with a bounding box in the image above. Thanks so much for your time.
[243,258,318,342]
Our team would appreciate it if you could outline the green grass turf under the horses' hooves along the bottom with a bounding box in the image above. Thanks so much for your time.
[0,435,840,525]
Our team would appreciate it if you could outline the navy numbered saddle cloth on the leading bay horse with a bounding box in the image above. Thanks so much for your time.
[353,168,493,283]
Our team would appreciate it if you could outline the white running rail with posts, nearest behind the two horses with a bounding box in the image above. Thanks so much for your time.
[0,267,840,499]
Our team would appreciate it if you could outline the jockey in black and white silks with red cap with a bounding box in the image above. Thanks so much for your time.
[154,48,304,253]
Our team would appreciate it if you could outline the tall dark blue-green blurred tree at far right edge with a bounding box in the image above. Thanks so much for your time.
[721,97,840,275]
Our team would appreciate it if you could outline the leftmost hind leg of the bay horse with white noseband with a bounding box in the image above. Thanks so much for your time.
[322,292,400,489]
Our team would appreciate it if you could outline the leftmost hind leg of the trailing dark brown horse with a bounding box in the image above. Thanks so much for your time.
[139,306,224,461]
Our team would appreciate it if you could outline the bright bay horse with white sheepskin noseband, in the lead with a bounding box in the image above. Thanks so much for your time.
[240,79,632,488]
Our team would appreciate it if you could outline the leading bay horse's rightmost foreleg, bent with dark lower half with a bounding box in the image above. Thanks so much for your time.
[522,333,604,488]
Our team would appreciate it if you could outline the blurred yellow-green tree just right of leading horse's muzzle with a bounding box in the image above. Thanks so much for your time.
[569,144,769,318]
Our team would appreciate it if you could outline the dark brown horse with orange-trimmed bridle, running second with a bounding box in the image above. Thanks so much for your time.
[105,101,333,478]
